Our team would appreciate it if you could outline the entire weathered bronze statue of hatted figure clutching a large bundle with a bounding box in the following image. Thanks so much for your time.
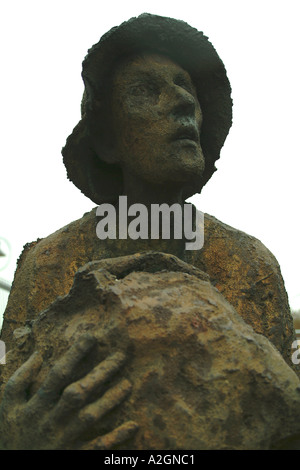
[0,15,300,449]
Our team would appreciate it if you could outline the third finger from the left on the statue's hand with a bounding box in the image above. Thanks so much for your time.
[53,352,126,421]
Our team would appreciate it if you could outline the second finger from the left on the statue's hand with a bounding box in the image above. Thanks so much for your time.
[36,334,96,402]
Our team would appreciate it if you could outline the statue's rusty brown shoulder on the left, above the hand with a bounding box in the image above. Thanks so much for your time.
[1,208,99,341]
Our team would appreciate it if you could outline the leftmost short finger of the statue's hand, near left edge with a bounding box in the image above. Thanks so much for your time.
[3,351,43,405]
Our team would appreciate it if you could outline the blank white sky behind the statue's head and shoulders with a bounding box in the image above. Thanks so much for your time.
[0,0,300,322]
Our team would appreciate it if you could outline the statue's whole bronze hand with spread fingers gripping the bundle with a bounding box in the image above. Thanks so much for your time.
[0,335,138,450]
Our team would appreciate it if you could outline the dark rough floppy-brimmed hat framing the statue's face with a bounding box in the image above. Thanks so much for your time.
[62,13,232,204]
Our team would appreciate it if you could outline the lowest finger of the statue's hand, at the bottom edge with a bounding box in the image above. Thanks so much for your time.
[79,421,139,450]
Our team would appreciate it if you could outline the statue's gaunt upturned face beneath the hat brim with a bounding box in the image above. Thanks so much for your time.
[112,54,204,186]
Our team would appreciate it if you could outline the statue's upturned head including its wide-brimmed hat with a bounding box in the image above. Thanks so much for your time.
[63,14,232,204]
